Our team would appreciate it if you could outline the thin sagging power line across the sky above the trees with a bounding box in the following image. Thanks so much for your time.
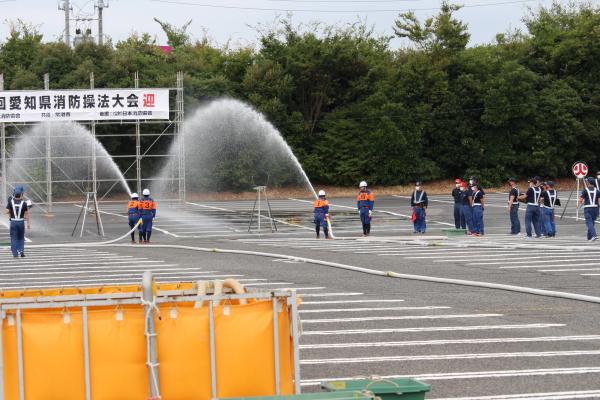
[150,0,540,13]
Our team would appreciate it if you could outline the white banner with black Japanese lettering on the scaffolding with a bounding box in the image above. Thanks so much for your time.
[0,89,169,122]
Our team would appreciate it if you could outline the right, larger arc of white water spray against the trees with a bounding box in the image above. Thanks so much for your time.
[153,99,316,198]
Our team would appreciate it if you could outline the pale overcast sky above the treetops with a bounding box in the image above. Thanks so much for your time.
[0,0,600,47]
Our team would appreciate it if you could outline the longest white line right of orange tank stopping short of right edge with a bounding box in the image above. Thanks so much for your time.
[302,324,565,335]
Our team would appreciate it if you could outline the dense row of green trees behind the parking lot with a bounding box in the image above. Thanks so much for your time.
[0,3,600,185]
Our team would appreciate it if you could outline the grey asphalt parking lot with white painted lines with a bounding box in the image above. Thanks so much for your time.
[0,194,600,399]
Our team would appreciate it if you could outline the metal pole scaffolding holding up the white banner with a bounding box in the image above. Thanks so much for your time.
[0,72,185,208]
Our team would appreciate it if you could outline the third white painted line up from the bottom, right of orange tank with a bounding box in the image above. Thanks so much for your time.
[300,350,600,365]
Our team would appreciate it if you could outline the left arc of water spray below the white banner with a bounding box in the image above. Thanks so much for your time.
[7,123,131,203]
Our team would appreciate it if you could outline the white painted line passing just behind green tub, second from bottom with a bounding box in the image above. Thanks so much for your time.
[301,367,600,386]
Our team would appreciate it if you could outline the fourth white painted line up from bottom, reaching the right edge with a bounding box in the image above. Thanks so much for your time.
[300,335,600,350]
